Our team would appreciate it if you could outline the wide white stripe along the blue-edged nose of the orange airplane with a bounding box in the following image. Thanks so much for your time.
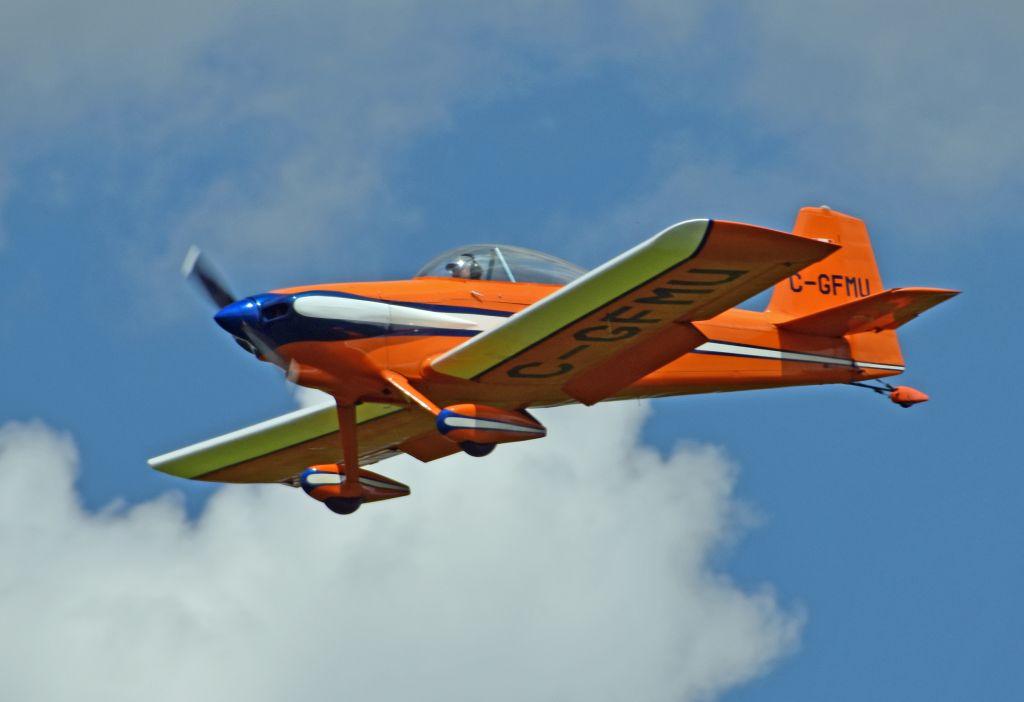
[294,295,508,332]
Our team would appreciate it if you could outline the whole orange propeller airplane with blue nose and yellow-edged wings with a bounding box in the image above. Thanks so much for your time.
[148,206,958,514]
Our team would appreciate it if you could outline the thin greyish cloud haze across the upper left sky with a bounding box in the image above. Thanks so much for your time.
[0,0,720,272]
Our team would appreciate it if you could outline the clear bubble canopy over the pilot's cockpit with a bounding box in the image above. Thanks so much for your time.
[416,244,587,286]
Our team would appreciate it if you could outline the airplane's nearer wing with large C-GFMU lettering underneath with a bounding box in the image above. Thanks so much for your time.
[431,219,838,404]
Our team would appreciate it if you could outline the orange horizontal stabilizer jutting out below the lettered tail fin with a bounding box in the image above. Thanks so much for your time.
[778,288,959,337]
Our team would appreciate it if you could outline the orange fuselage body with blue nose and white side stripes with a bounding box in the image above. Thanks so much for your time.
[217,277,903,407]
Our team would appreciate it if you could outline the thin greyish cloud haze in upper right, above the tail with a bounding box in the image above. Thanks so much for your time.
[536,0,1024,250]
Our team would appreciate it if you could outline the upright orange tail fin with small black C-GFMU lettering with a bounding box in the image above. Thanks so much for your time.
[768,207,884,317]
